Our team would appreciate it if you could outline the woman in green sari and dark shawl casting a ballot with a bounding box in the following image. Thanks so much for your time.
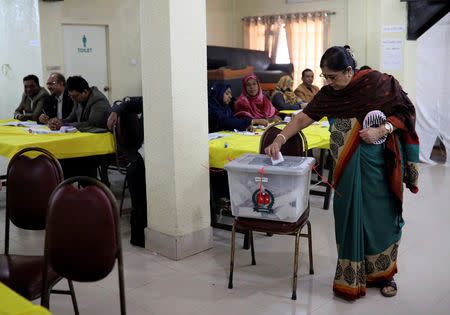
[265,46,419,300]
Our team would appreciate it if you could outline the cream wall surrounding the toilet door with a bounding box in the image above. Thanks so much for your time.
[39,0,142,102]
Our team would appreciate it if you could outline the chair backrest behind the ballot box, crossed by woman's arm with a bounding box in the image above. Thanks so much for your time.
[259,123,308,156]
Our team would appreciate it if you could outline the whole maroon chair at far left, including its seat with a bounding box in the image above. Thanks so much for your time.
[0,147,75,312]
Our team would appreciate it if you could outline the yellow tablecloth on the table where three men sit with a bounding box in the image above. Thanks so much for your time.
[0,119,115,159]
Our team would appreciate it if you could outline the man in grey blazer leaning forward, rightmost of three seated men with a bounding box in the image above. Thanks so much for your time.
[48,76,111,133]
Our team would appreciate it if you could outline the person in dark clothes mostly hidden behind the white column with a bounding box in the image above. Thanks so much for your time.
[108,98,147,247]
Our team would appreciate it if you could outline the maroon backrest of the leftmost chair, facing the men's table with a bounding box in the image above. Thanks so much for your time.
[5,147,64,233]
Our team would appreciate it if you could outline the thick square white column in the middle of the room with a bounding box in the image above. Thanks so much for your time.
[140,0,212,260]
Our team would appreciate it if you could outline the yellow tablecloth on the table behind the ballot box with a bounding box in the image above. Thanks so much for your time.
[209,125,330,168]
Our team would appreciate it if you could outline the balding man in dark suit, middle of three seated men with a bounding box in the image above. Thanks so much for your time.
[39,72,73,124]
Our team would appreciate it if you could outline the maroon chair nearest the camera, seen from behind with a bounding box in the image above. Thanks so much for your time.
[41,176,126,314]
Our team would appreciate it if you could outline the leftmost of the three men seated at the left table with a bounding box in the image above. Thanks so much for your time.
[14,74,49,121]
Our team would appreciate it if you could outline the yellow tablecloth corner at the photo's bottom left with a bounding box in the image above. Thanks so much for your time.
[0,282,51,315]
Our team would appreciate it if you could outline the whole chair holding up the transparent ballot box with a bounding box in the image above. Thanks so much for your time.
[228,125,314,300]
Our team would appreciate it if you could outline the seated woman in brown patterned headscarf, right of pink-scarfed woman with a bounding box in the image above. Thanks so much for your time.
[270,75,306,110]
